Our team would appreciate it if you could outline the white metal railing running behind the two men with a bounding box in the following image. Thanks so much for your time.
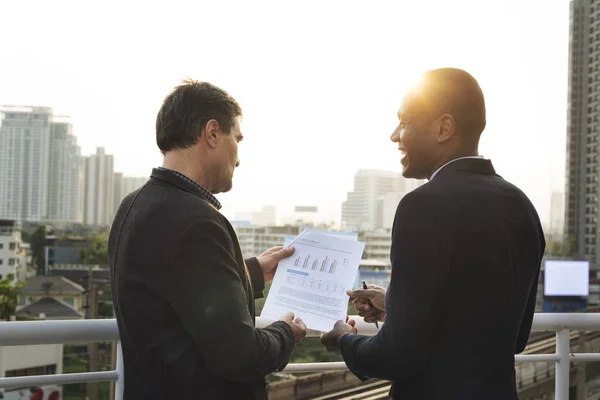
[0,313,600,400]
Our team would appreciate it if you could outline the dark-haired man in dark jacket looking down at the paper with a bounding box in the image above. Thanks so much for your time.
[109,81,306,400]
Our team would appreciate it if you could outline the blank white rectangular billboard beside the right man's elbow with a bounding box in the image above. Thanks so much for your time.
[544,260,590,296]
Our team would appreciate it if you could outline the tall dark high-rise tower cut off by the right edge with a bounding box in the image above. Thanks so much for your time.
[565,0,600,269]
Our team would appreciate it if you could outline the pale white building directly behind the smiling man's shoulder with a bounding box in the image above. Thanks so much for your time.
[342,170,422,232]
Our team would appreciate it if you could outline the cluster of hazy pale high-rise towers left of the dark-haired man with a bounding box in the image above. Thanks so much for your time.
[0,106,147,226]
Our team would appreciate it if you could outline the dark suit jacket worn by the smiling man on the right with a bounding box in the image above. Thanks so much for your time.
[341,159,545,400]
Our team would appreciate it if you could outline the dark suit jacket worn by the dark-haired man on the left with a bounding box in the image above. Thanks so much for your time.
[109,169,293,400]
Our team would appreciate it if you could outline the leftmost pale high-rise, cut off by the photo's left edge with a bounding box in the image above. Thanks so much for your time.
[0,106,52,223]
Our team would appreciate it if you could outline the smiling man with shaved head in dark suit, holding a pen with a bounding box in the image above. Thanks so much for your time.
[322,68,545,400]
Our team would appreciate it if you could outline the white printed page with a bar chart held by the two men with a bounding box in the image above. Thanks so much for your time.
[261,232,365,331]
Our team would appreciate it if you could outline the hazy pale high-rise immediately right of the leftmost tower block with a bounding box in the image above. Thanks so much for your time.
[48,117,84,223]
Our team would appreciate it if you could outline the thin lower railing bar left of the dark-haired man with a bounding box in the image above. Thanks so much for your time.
[0,371,119,388]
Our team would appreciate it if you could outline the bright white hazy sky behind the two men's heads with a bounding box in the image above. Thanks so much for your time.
[0,0,569,225]
